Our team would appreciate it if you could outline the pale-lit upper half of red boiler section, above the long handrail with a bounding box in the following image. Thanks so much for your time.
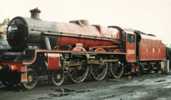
[56,23,120,40]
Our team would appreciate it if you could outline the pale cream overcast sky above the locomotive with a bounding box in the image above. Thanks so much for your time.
[0,0,171,43]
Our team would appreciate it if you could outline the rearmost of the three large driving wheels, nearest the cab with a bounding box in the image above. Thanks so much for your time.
[109,62,124,79]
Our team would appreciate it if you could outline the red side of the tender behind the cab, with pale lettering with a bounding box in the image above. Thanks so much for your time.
[139,36,166,61]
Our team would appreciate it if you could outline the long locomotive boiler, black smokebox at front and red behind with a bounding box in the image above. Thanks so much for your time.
[7,10,122,50]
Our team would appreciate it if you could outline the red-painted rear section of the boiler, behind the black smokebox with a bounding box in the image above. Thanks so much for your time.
[56,23,120,48]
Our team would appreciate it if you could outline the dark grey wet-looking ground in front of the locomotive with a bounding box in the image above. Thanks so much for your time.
[0,74,171,100]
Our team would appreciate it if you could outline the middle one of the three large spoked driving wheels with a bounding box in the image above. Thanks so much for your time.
[90,63,108,81]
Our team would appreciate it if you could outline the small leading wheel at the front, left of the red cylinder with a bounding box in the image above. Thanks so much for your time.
[22,68,38,90]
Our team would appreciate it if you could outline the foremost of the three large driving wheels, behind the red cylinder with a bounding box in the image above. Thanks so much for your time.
[68,61,90,83]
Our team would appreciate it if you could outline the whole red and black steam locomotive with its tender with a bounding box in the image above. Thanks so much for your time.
[0,8,169,89]
